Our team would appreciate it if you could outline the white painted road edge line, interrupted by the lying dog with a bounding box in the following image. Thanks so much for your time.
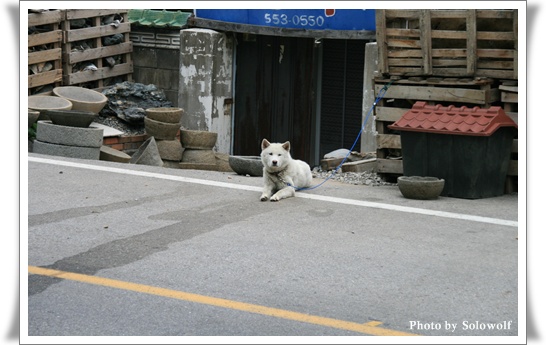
[28,157,518,227]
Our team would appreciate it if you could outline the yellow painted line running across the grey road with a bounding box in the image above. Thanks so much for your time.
[28,266,417,336]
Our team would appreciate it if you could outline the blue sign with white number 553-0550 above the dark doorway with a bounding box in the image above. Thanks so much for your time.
[191,9,375,31]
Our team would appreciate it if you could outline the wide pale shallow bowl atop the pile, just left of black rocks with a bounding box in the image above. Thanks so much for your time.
[53,86,108,114]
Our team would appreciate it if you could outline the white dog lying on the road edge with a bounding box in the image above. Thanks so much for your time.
[260,139,313,201]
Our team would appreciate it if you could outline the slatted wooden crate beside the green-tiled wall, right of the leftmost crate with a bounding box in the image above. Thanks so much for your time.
[63,9,133,88]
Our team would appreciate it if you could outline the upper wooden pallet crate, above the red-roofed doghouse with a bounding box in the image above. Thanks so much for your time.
[376,9,518,79]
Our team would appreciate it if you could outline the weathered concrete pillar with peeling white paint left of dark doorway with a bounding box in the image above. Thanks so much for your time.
[178,29,233,154]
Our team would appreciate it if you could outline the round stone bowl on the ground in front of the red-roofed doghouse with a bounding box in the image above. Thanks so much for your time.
[398,176,445,200]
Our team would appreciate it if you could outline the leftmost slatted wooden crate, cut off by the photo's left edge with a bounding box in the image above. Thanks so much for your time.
[28,10,64,95]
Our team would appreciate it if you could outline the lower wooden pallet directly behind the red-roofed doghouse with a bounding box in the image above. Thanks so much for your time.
[374,77,500,182]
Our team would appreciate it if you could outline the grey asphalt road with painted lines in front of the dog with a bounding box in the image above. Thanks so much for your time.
[21,154,525,344]
